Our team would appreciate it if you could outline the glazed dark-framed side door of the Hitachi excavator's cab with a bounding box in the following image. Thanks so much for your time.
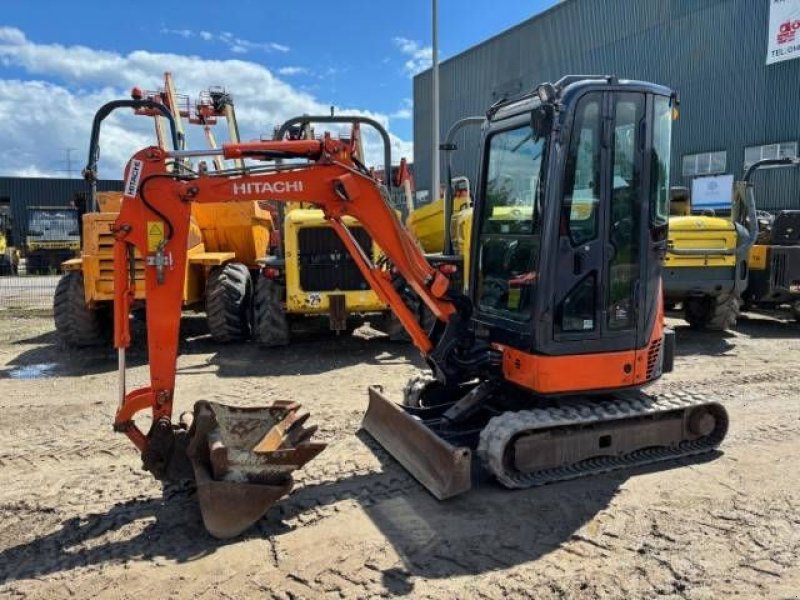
[542,92,647,355]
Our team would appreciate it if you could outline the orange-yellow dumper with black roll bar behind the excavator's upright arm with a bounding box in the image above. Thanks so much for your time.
[53,100,273,347]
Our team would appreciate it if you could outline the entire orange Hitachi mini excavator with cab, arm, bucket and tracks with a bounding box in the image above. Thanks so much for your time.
[103,76,728,537]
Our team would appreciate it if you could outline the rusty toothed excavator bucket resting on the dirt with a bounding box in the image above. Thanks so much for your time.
[187,401,325,539]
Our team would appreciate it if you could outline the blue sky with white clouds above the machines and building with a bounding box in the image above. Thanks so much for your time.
[0,0,555,175]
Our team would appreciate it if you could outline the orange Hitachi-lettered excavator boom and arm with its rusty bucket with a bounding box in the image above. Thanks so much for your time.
[113,130,462,537]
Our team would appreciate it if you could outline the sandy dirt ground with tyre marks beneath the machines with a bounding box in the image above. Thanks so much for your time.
[0,311,800,598]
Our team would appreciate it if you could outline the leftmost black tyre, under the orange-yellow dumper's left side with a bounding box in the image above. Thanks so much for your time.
[53,271,114,348]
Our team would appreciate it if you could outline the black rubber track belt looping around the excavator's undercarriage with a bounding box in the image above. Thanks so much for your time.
[478,391,728,489]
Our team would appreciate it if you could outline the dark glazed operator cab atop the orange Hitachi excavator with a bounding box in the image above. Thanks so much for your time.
[470,79,675,360]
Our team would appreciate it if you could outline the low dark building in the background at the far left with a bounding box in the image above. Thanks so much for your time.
[0,177,122,244]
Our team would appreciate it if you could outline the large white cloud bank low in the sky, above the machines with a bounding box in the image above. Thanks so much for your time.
[0,27,412,179]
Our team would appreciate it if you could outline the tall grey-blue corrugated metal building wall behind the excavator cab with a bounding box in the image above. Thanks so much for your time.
[414,0,800,210]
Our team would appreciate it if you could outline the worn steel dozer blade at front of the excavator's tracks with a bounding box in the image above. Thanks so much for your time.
[361,386,472,500]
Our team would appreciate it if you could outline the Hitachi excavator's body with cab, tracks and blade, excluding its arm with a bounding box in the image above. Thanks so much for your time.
[363,77,727,499]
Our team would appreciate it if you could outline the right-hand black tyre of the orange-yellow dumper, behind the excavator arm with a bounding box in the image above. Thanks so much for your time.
[206,263,253,342]
